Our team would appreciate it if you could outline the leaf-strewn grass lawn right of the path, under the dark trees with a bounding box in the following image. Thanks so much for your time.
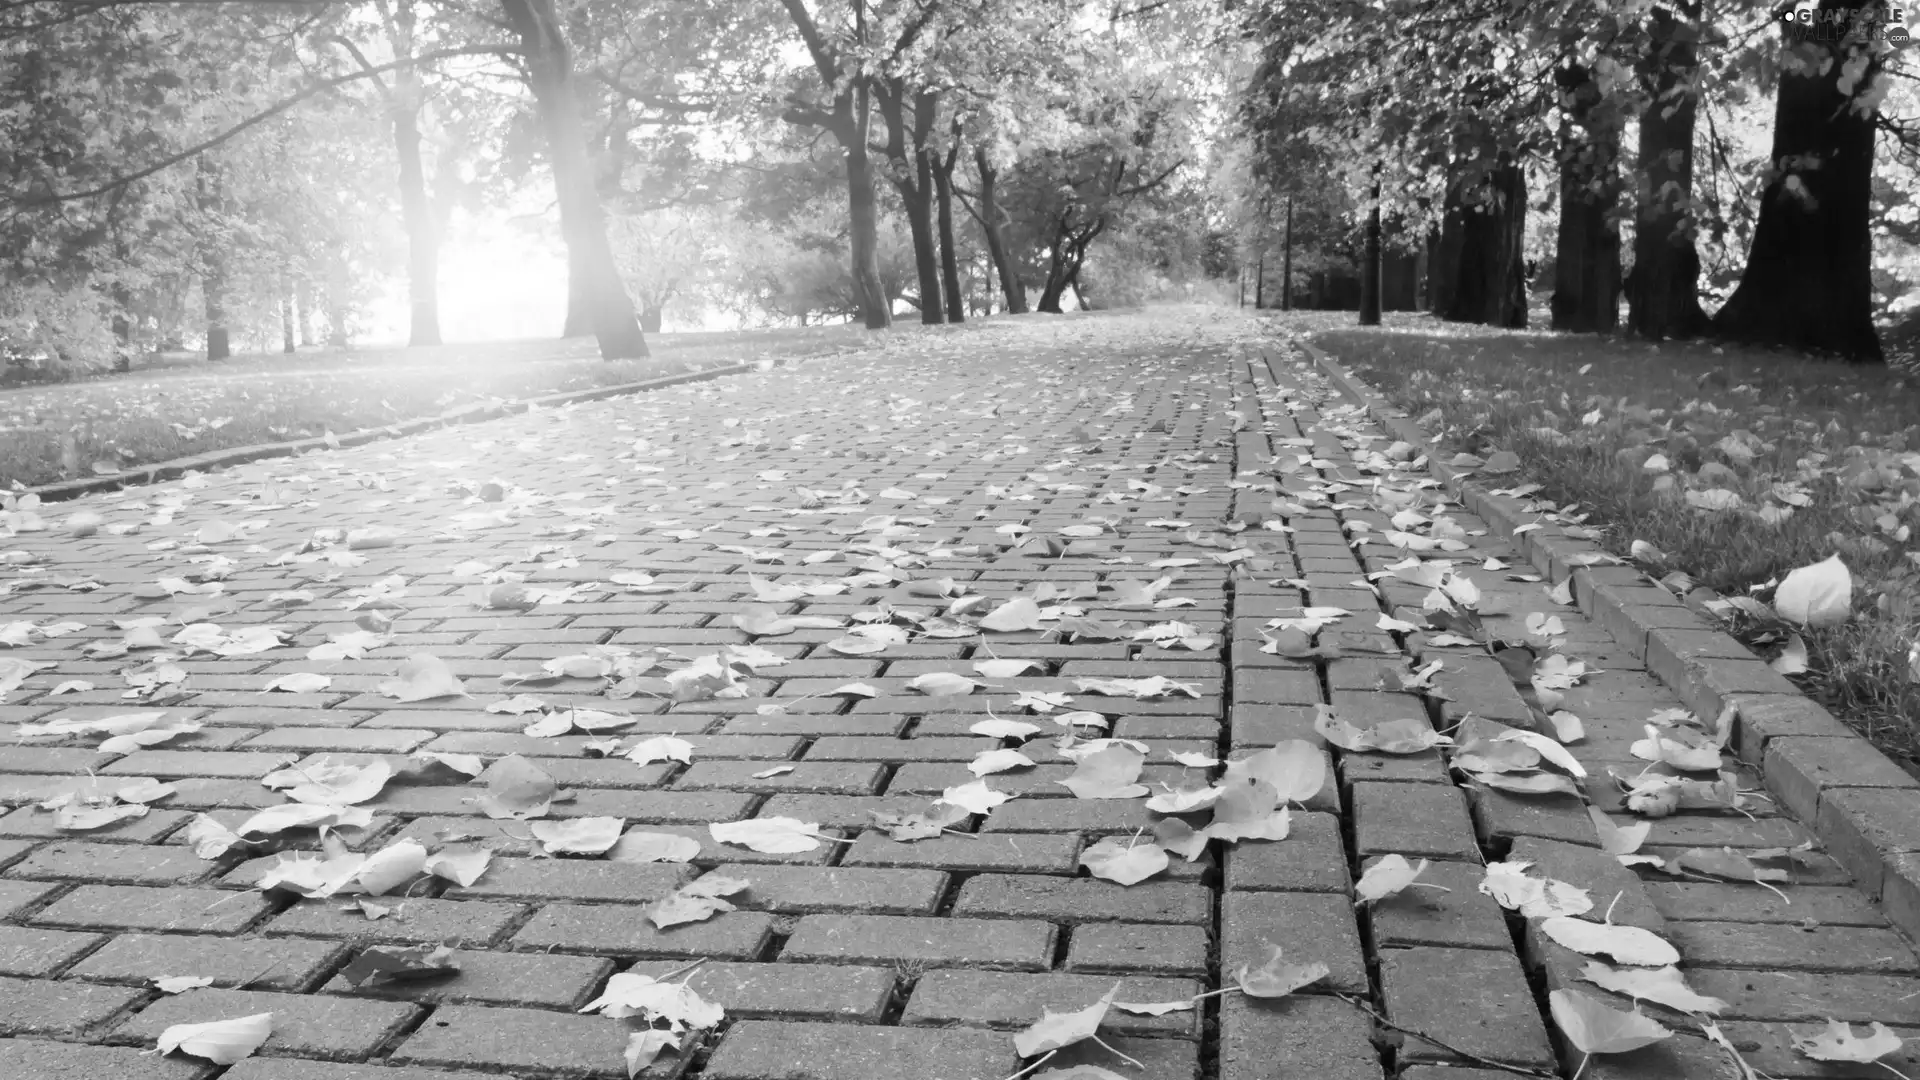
[1288,313,1920,767]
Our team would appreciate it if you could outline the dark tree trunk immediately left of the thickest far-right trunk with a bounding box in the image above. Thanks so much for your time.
[1626,0,1707,340]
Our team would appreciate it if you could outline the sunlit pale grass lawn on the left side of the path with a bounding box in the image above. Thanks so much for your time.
[0,319,887,488]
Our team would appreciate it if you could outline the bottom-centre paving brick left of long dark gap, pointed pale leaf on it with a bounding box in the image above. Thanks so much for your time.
[900,970,1200,1038]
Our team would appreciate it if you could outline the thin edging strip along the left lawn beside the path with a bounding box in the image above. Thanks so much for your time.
[24,359,756,502]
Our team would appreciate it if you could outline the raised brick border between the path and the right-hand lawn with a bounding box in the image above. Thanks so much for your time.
[1294,332,1920,938]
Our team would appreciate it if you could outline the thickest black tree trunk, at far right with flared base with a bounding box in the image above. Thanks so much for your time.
[1713,0,1885,363]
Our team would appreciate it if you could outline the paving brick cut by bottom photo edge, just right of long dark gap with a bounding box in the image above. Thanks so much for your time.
[1219,994,1384,1080]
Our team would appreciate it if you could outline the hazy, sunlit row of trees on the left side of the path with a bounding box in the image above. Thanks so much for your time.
[0,0,1233,368]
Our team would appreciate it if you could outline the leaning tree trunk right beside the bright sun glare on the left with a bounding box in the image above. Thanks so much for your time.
[501,0,647,359]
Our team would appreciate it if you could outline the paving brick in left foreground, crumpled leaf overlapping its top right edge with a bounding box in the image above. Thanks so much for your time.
[518,901,774,961]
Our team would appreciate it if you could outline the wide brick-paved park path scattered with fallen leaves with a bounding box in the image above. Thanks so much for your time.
[0,309,1920,1080]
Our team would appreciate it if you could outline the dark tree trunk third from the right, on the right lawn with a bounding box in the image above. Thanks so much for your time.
[1549,65,1620,332]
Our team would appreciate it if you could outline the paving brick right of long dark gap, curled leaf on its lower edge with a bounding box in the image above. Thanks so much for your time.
[1219,892,1367,994]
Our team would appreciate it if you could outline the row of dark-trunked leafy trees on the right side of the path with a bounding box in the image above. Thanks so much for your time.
[1242,0,1920,361]
